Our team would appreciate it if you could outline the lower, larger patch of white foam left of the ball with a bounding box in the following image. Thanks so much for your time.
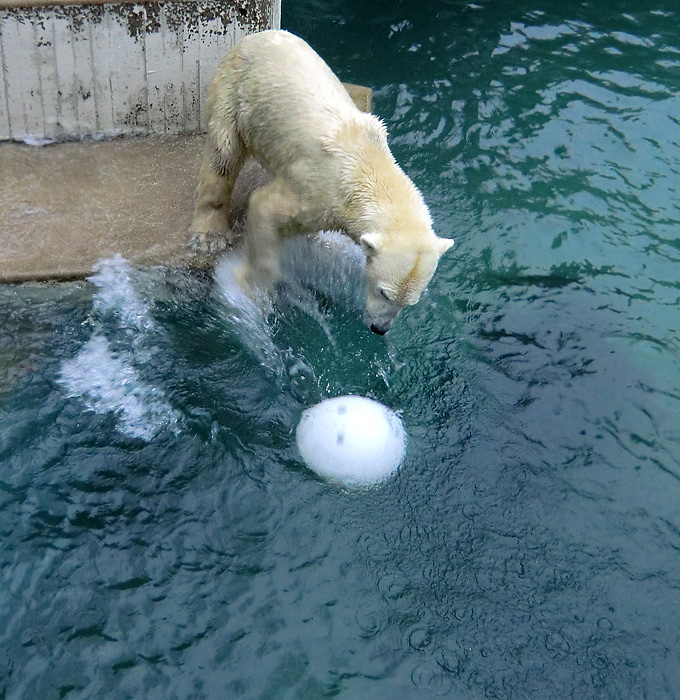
[60,335,181,441]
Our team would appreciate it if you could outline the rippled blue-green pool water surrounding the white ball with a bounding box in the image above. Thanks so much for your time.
[0,0,680,700]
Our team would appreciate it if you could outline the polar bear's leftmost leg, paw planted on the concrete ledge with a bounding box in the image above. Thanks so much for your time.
[189,133,245,254]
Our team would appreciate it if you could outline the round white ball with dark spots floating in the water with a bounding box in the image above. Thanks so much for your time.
[296,396,406,486]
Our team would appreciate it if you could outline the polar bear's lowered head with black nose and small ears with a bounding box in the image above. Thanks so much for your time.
[360,232,453,335]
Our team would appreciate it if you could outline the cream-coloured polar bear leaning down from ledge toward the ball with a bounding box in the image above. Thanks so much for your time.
[191,30,453,335]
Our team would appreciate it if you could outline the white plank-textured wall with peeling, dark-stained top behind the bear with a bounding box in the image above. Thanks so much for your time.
[0,0,281,142]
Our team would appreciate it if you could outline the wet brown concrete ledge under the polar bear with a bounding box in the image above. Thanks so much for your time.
[0,86,371,282]
